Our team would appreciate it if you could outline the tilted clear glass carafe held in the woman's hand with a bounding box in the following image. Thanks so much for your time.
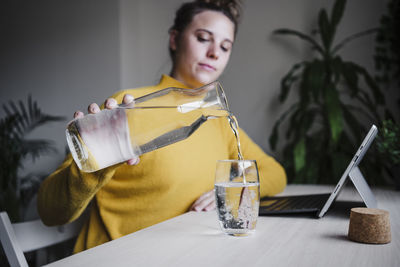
[66,82,229,172]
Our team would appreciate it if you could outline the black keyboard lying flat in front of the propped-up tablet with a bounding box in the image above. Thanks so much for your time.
[260,194,330,215]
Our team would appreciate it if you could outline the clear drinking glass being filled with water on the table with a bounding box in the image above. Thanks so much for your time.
[215,160,260,236]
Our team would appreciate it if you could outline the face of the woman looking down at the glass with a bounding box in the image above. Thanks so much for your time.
[170,11,234,88]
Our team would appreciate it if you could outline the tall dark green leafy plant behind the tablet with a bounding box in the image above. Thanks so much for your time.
[269,0,385,183]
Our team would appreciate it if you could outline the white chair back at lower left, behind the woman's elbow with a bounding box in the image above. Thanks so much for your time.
[0,211,85,267]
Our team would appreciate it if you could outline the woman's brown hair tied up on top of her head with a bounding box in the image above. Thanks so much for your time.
[169,0,241,59]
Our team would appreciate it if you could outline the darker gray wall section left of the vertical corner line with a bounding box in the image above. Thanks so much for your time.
[0,0,120,176]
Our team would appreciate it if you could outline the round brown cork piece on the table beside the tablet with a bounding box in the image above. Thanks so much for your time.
[348,208,391,244]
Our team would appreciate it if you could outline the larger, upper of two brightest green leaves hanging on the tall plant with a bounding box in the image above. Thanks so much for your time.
[325,84,343,144]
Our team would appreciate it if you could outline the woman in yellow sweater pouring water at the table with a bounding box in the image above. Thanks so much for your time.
[38,1,286,252]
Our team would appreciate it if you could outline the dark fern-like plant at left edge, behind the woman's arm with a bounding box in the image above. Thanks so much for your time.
[0,96,65,222]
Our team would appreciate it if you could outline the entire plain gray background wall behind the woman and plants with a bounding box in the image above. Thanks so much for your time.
[0,0,393,178]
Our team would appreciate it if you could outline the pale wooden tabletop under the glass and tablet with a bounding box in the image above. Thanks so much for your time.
[43,185,400,267]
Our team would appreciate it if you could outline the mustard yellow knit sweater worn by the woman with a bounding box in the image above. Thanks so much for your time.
[38,75,286,252]
